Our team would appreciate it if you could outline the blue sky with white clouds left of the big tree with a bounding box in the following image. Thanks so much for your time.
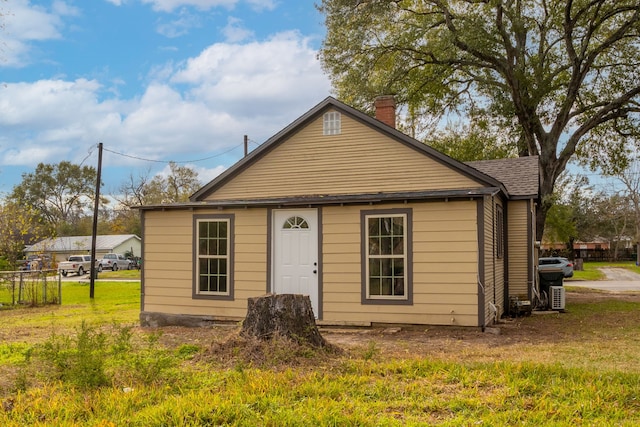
[0,0,331,195]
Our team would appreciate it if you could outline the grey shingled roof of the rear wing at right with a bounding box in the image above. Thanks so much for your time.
[466,156,540,199]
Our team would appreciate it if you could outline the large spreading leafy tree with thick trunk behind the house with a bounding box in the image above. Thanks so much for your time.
[319,0,640,239]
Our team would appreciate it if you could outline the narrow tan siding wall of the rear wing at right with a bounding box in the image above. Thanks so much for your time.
[507,200,530,299]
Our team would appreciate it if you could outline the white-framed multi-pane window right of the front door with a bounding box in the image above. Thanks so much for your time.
[362,209,412,303]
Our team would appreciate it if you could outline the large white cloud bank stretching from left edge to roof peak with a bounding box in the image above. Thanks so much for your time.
[0,32,330,182]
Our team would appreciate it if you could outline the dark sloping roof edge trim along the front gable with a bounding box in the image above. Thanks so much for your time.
[190,97,508,203]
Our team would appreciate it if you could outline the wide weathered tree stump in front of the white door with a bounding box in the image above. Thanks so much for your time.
[241,294,327,347]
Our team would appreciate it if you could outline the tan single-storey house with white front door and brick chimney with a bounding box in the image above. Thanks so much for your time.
[140,97,538,327]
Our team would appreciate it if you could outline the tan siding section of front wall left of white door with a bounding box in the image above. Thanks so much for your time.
[143,209,267,318]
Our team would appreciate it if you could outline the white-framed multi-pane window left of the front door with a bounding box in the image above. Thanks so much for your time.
[194,215,238,298]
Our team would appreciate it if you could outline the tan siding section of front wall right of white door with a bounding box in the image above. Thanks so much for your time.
[322,201,478,326]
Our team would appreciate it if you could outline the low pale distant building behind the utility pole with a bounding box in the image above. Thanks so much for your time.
[25,234,142,265]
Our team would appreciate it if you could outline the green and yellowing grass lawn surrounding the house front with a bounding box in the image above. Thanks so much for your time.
[0,281,640,426]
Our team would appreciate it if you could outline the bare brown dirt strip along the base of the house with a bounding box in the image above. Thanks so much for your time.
[152,291,640,365]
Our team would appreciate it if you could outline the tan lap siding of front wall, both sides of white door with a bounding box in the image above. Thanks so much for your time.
[143,201,479,326]
